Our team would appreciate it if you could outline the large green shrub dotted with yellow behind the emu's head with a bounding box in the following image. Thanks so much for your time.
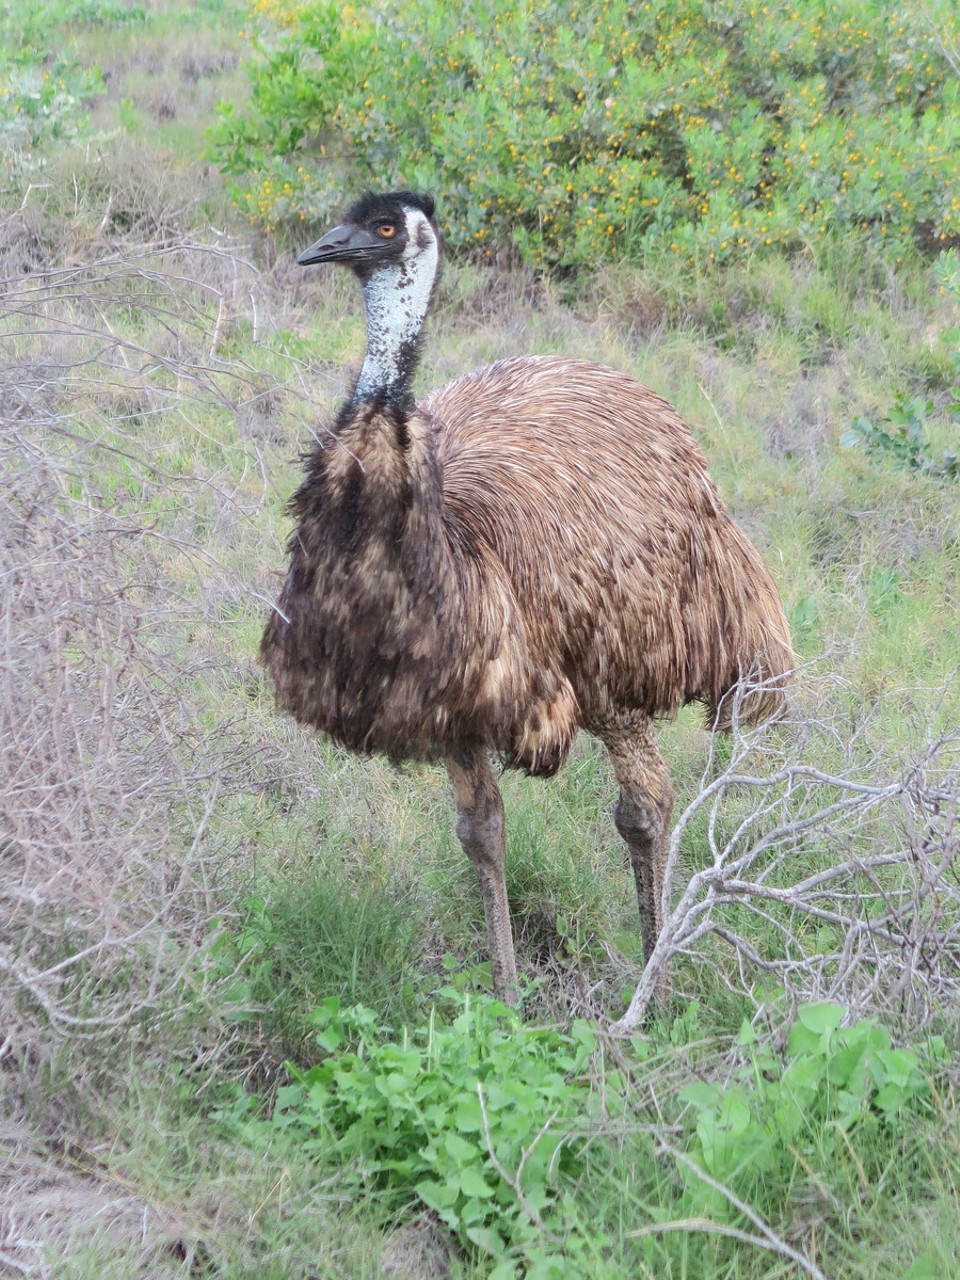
[215,0,960,265]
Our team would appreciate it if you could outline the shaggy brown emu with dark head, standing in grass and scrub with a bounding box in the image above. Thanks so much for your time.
[261,192,792,1000]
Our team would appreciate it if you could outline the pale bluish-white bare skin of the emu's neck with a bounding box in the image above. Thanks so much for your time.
[353,207,440,402]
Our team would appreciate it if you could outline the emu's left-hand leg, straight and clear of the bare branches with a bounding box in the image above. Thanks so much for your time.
[447,751,517,1005]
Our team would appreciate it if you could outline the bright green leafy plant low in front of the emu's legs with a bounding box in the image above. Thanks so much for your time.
[273,988,622,1280]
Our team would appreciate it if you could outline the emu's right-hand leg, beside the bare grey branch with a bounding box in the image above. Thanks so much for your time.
[599,717,673,998]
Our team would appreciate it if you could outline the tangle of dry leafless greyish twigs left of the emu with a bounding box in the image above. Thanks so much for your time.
[0,235,302,1061]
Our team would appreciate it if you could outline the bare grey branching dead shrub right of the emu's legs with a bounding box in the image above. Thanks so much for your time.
[613,675,960,1033]
